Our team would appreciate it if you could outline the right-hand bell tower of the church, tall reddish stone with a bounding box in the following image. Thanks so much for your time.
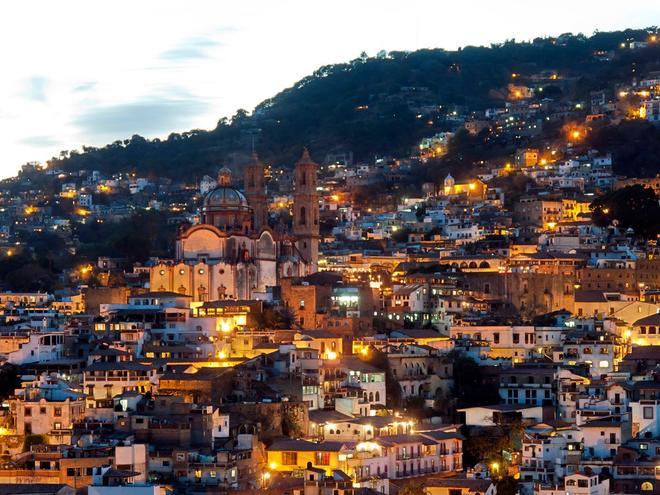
[293,149,319,273]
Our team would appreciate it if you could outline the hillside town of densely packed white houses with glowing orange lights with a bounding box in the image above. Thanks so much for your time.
[0,28,660,495]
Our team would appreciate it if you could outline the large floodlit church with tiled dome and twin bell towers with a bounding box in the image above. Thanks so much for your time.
[149,150,319,302]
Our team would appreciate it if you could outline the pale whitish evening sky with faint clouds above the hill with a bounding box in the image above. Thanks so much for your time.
[0,0,660,177]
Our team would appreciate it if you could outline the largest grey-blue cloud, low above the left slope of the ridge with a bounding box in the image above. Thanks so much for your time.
[72,96,207,141]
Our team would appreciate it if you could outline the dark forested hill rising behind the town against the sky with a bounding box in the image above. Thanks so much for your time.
[50,30,660,177]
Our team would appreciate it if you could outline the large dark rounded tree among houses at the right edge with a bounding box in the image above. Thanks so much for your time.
[590,185,660,238]
